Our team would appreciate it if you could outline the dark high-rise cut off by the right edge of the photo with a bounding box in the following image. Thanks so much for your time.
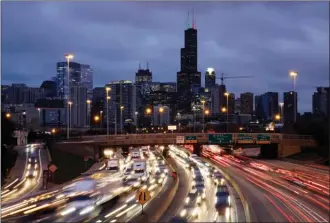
[313,87,329,115]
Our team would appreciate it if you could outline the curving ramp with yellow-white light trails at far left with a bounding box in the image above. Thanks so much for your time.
[1,144,48,205]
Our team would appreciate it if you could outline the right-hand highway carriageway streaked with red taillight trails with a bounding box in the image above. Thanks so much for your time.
[200,147,329,222]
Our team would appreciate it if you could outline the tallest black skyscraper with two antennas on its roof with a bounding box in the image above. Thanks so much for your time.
[177,12,201,111]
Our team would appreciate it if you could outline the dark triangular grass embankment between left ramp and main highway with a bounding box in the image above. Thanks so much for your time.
[49,142,95,184]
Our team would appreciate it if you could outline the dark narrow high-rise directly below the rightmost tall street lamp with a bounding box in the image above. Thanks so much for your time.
[283,91,298,123]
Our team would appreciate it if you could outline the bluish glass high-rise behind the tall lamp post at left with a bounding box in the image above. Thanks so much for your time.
[56,62,81,99]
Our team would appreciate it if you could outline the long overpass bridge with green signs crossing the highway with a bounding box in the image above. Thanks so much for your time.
[57,133,316,159]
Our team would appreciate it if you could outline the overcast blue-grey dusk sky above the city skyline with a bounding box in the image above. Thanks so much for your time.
[1,2,329,111]
